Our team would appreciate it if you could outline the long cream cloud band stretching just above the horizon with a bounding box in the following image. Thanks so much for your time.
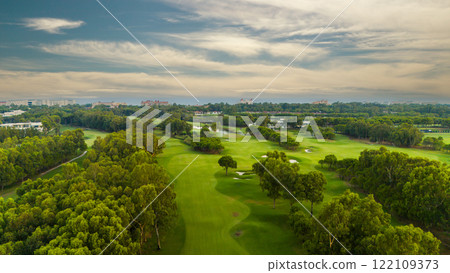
[0,59,450,102]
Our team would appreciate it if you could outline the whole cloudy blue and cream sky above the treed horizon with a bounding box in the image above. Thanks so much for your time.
[0,0,450,104]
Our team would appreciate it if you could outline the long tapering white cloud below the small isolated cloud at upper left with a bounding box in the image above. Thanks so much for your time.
[39,41,290,74]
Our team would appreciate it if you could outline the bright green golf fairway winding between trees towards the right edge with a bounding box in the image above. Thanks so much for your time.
[158,132,450,254]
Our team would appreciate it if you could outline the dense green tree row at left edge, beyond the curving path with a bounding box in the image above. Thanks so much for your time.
[0,129,86,191]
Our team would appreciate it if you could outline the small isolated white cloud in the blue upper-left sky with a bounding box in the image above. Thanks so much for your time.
[23,18,85,34]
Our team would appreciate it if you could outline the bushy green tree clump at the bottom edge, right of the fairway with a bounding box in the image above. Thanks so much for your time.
[289,190,440,255]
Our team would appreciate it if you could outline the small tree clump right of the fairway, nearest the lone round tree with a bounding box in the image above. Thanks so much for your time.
[252,151,327,210]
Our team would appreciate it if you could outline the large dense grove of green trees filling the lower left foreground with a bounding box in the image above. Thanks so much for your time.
[0,132,176,254]
